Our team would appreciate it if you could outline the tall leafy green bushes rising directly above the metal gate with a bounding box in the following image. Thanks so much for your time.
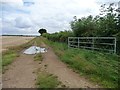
[70,3,120,37]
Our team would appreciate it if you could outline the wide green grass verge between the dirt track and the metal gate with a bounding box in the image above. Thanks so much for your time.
[43,39,120,88]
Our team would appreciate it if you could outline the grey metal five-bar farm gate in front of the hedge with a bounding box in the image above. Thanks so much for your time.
[68,37,116,54]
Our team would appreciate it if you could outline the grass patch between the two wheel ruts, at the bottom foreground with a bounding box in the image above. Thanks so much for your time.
[36,72,60,88]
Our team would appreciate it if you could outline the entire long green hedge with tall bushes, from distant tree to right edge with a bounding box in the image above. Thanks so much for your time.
[43,3,120,54]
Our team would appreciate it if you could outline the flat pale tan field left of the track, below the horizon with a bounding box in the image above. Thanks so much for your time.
[0,36,34,52]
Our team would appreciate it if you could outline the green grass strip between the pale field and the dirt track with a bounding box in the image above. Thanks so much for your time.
[1,38,37,73]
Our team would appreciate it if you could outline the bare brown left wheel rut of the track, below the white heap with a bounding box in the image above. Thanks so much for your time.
[2,54,39,88]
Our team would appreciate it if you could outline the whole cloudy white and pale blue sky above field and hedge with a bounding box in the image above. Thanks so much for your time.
[0,0,119,35]
